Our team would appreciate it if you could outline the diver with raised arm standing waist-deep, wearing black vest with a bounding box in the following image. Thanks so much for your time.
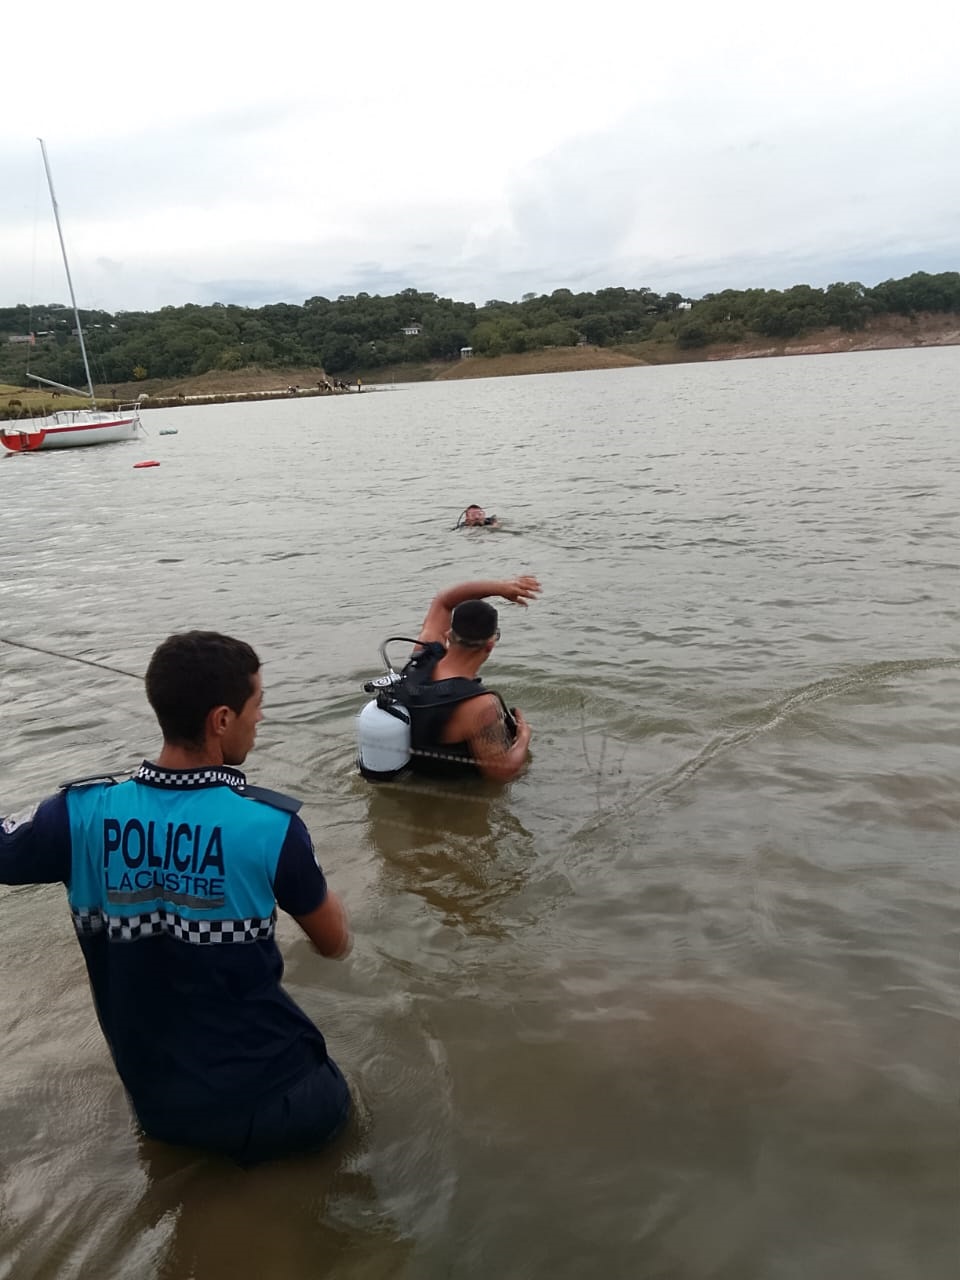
[397,575,540,782]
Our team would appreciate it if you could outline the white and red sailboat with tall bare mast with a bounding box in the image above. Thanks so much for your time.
[0,138,141,453]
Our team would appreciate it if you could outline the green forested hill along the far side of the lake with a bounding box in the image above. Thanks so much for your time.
[0,271,960,385]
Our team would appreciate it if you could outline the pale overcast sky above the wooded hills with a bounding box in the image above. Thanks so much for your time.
[0,0,960,311]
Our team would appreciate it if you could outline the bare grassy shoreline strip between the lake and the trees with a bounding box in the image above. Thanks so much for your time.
[0,315,960,419]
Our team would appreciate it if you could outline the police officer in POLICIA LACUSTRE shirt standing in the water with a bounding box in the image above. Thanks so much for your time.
[0,631,351,1165]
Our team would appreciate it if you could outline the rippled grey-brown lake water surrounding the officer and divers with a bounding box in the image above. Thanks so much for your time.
[0,348,960,1280]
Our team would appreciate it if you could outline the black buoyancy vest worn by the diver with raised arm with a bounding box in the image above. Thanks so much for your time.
[396,641,516,776]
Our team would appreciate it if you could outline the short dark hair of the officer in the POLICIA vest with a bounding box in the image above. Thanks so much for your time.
[146,631,260,746]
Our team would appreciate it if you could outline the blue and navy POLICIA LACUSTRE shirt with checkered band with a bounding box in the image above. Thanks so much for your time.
[0,762,326,1120]
